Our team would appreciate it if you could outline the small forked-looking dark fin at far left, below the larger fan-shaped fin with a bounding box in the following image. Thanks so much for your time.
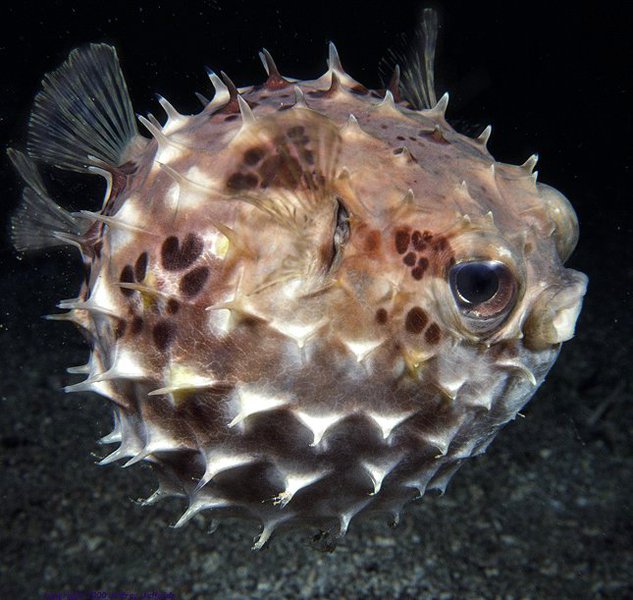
[7,148,85,251]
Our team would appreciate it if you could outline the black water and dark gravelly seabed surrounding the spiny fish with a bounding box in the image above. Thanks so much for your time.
[0,0,633,600]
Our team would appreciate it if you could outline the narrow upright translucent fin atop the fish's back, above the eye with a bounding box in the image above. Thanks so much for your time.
[380,8,438,110]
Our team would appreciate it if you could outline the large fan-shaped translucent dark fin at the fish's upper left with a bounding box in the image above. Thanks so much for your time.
[27,44,138,172]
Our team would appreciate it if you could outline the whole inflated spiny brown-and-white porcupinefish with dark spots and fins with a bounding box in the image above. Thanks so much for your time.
[9,11,587,548]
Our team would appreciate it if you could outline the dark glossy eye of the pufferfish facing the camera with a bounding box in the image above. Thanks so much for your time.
[450,260,517,324]
